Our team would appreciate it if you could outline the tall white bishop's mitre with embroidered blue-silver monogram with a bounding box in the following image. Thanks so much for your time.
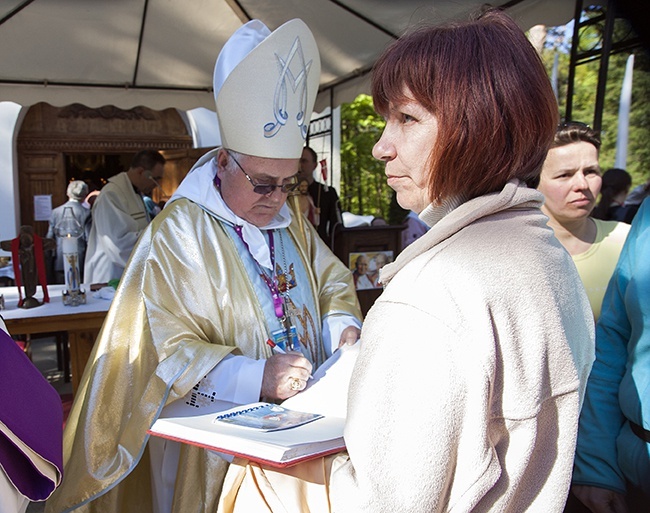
[214,19,320,159]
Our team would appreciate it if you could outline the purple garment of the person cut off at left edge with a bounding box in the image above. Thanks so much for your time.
[0,329,63,501]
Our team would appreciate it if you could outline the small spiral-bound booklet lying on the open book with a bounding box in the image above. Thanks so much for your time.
[214,403,323,431]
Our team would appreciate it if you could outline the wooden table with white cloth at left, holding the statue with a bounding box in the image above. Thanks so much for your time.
[0,285,111,394]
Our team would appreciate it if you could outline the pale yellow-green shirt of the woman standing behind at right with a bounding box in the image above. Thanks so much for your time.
[573,219,630,321]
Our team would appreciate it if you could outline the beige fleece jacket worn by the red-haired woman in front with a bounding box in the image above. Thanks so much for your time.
[329,182,594,513]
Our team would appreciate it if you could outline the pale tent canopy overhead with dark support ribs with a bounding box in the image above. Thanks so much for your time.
[0,0,574,111]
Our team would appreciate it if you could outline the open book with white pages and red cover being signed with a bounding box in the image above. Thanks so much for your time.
[149,344,358,467]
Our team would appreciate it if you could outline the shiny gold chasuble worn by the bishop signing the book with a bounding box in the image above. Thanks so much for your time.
[46,199,361,513]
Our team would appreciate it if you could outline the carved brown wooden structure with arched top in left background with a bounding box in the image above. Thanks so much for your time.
[17,103,197,236]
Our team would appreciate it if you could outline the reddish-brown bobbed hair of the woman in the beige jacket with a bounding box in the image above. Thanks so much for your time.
[372,10,558,201]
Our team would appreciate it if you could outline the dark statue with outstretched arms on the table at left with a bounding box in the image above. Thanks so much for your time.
[0,226,56,308]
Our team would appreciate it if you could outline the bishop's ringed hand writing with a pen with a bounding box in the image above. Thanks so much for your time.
[260,352,312,400]
